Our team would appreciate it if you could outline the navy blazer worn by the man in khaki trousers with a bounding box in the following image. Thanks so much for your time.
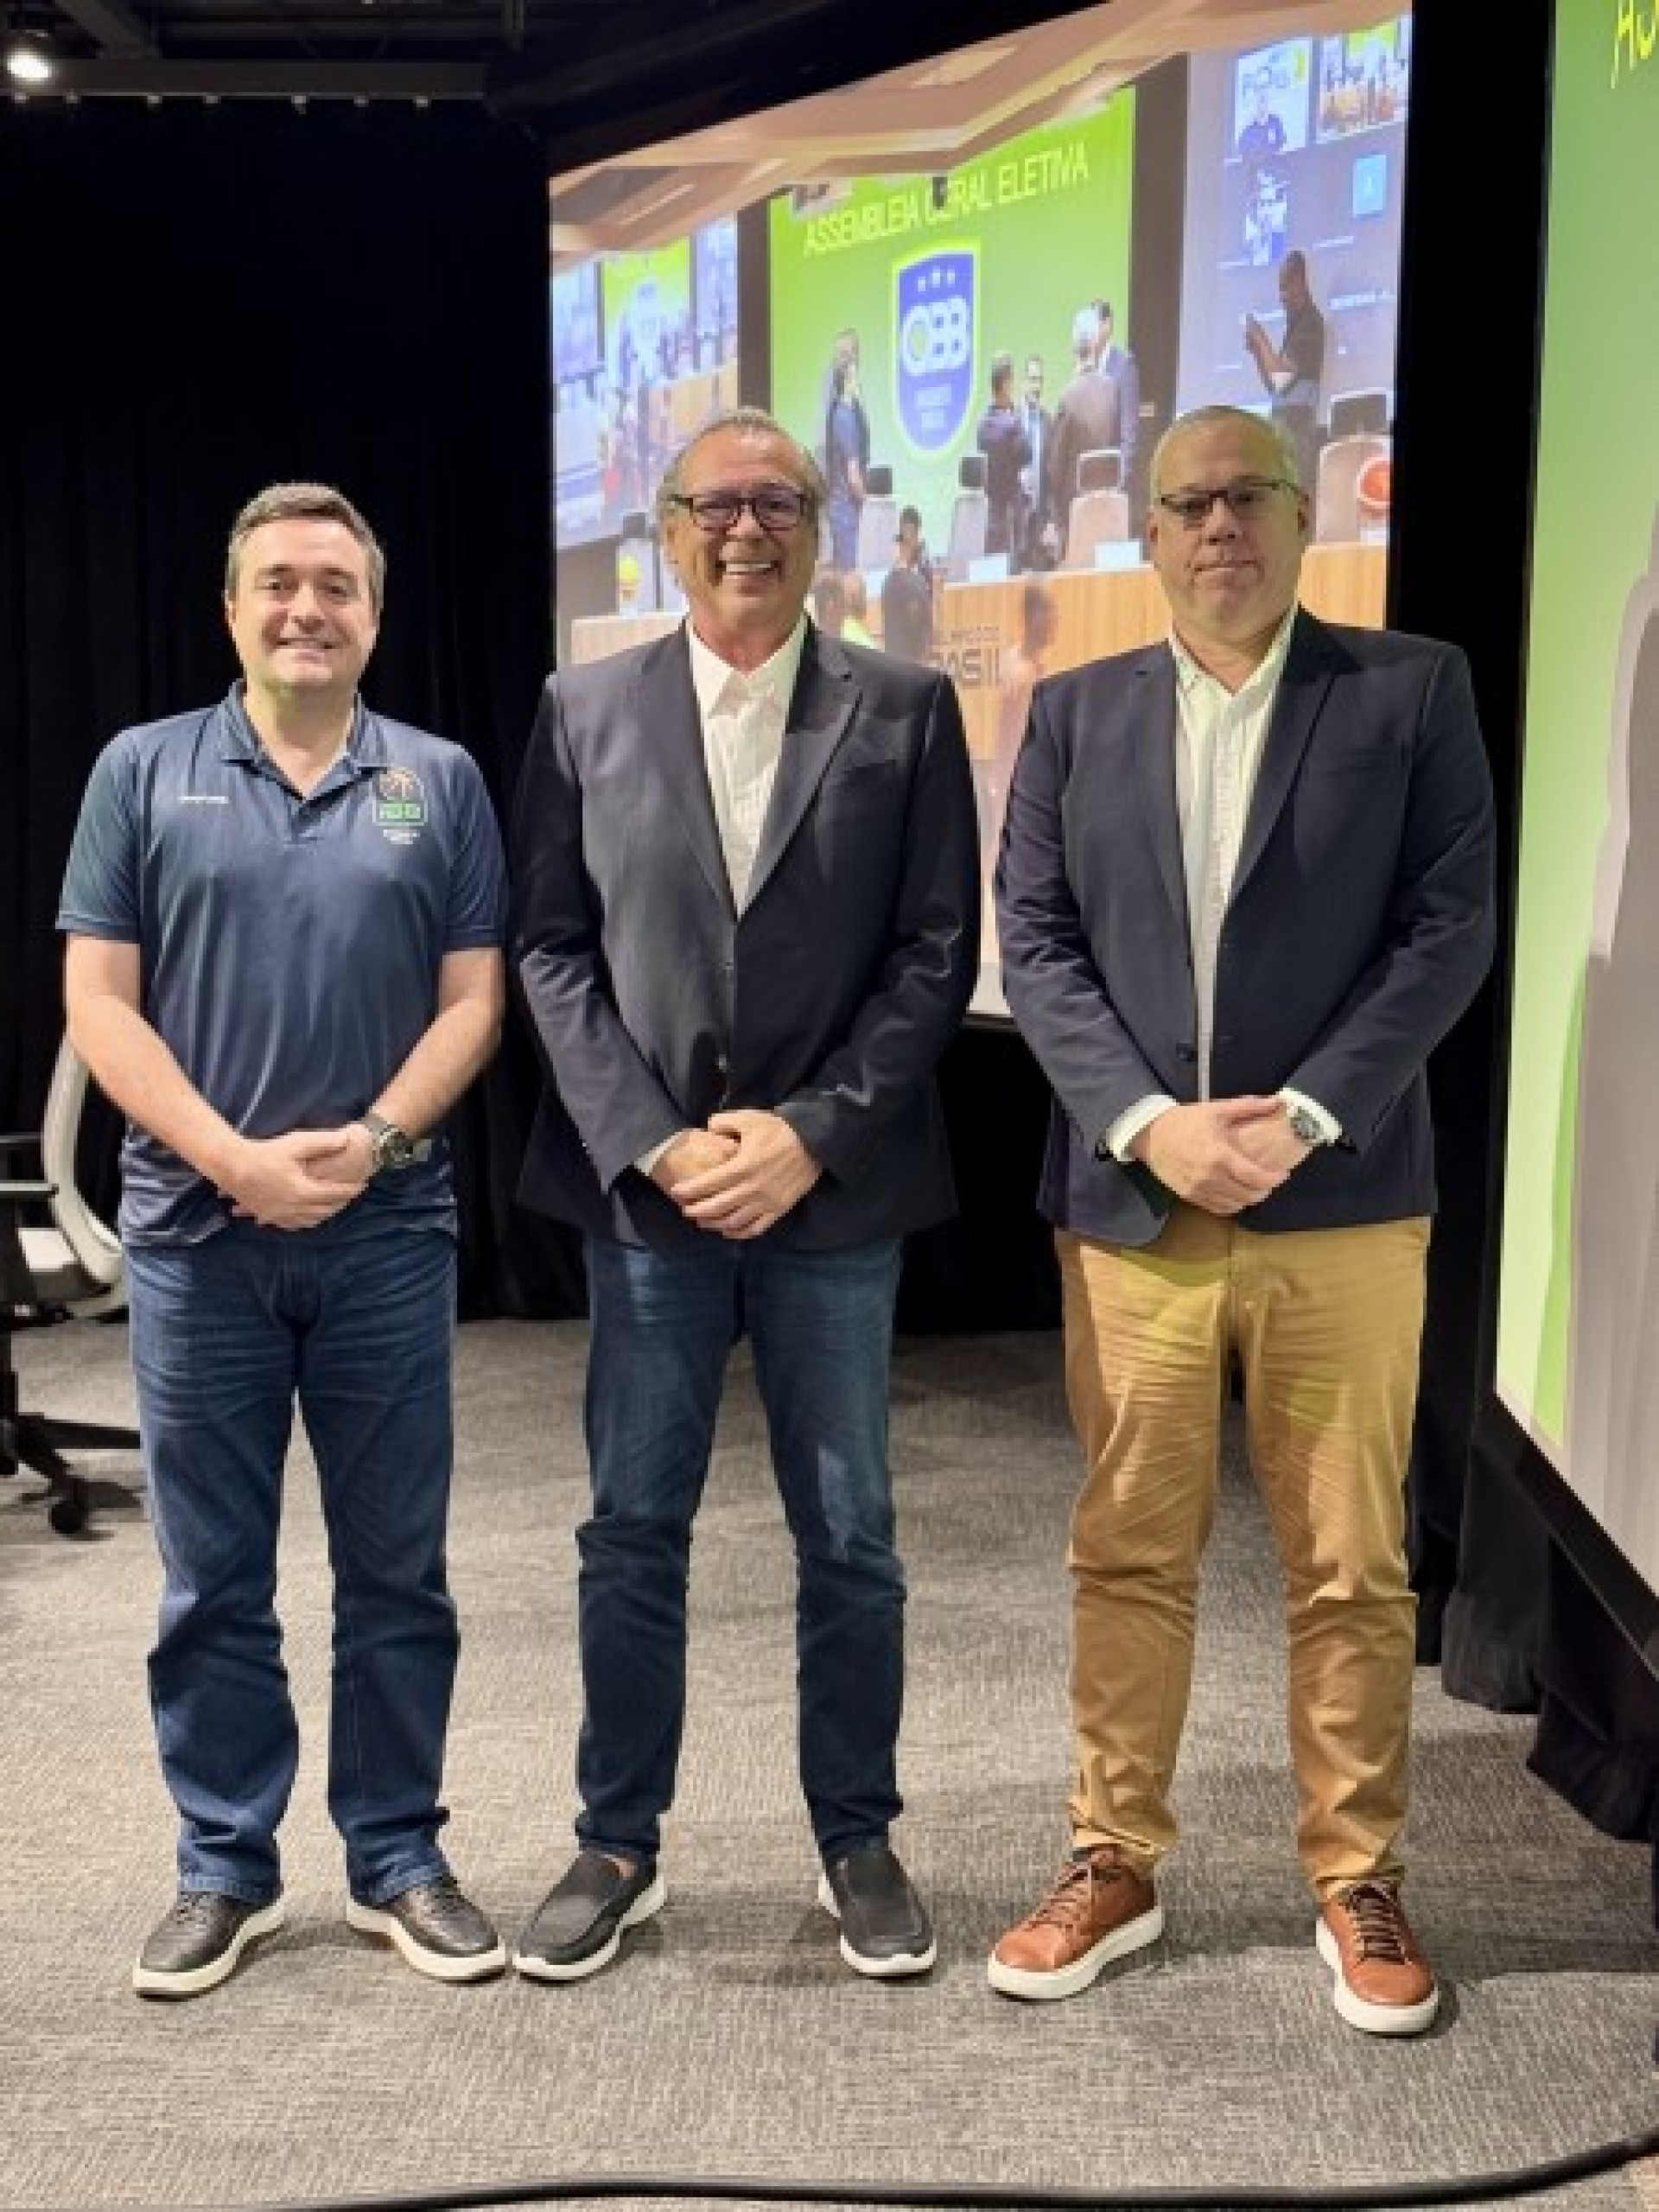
[995,613,1493,1245]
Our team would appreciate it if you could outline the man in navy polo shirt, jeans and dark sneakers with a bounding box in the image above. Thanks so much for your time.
[58,485,505,1998]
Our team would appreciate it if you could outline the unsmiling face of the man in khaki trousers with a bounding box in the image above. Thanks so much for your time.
[1146,411,1307,675]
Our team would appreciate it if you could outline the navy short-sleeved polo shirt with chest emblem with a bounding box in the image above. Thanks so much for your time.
[58,683,506,1243]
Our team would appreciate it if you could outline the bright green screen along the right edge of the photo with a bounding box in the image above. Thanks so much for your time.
[1503,0,1659,1584]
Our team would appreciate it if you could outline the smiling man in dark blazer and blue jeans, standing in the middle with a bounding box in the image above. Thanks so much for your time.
[511,410,980,1982]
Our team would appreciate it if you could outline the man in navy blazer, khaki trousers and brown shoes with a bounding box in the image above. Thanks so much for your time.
[988,407,1493,2035]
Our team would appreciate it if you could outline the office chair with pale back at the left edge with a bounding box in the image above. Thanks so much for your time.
[0,1042,139,1535]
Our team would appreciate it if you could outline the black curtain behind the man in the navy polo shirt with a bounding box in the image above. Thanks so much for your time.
[0,102,580,1314]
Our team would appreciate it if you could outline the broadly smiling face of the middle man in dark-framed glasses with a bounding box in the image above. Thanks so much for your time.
[664,429,818,668]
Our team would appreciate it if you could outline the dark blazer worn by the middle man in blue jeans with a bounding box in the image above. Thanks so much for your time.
[511,626,980,1249]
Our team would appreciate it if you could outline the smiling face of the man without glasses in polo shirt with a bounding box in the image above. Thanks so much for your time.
[226,518,380,710]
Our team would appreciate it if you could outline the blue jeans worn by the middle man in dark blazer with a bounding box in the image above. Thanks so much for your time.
[575,1236,905,1860]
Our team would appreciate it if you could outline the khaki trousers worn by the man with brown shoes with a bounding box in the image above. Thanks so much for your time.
[1055,1204,1429,1896]
